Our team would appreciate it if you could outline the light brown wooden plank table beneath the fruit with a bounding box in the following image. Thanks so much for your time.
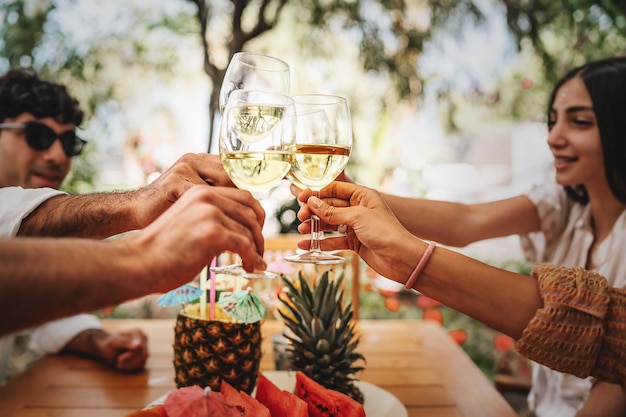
[0,320,517,417]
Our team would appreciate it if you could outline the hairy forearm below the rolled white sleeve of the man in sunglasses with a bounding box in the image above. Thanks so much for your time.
[18,192,138,238]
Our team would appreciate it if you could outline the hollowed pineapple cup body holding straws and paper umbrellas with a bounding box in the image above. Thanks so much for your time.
[174,306,261,394]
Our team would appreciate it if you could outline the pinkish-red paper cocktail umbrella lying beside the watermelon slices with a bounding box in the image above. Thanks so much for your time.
[165,385,241,417]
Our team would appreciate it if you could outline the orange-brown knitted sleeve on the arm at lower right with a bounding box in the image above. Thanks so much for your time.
[515,264,610,378]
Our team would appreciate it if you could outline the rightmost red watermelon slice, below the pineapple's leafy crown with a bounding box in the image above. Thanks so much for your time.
[296,371,365,417]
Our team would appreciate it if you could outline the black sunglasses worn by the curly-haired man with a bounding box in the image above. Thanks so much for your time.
[0,122,87,158]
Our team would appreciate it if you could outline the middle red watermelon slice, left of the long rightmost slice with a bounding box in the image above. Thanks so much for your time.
[256,374,309,417]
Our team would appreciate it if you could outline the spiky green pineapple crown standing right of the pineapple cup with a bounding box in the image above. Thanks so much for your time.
[279,272,365,403]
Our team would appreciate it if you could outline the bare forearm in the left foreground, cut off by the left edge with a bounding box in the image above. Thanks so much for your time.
[0,238,145,334]
